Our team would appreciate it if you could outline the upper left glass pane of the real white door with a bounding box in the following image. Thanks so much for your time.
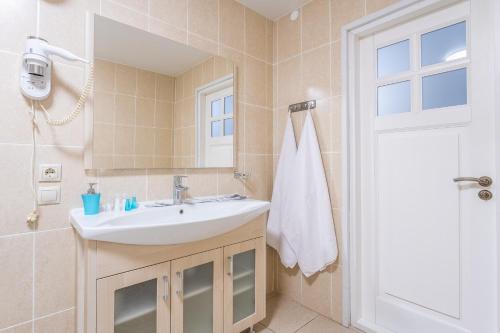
[377,39,410,77]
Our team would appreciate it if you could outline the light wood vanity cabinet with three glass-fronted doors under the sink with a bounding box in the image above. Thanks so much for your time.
[77,215,266,333]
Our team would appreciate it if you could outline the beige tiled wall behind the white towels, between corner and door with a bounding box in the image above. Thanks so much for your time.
[273,0,395,322]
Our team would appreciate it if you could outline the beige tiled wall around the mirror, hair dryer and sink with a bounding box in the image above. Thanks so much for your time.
[0,0,273,333]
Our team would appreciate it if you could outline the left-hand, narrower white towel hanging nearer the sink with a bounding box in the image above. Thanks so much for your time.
[267,114,297,268]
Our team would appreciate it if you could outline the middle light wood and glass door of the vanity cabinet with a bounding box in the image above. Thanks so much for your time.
[172,249,223,333]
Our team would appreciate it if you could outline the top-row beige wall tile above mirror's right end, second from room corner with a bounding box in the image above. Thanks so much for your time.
[220,0,245,51]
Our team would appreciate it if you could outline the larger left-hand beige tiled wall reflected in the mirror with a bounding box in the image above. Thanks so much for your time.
[92,59,175,169]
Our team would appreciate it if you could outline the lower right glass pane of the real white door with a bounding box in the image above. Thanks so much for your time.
[422,68,467,110]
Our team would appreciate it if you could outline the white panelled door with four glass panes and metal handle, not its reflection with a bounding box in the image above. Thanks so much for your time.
[358,0,498,333]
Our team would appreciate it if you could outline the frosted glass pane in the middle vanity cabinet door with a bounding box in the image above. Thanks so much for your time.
[183,262,214,333]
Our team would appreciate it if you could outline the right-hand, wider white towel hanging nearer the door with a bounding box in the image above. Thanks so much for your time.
[283,111,338,277]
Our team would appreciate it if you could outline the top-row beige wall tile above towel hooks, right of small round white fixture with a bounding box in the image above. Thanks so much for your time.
[301,0,334,51]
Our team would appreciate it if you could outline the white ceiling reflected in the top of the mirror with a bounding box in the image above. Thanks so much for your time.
[94,15,212,76]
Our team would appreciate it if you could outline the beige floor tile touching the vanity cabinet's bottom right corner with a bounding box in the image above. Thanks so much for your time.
[262,296,318,333]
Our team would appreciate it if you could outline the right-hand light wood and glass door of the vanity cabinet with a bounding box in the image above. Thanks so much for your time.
[224,237,266,333]
